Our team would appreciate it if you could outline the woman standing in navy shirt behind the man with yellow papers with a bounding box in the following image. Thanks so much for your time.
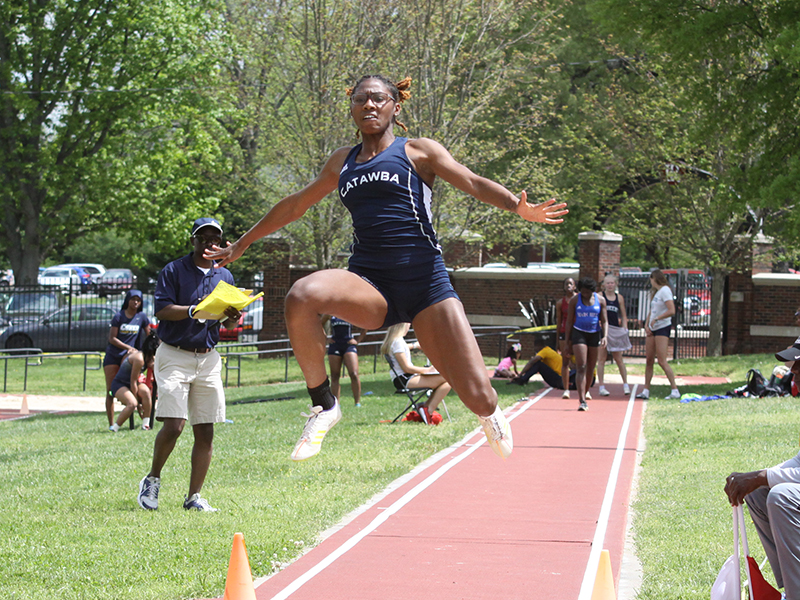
[103,290,150,428]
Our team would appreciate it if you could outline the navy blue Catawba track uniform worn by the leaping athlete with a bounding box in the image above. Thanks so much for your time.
[339,138,458,327]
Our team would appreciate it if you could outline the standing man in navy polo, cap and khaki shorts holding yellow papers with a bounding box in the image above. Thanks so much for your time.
[138,217,241,511]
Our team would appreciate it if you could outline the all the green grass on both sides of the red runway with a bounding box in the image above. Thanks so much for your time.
[0,355,800,600]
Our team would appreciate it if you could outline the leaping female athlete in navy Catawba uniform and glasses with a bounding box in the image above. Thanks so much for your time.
[206,75,568,460]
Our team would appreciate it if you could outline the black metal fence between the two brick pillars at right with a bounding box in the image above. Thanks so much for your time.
[619,270,711,359]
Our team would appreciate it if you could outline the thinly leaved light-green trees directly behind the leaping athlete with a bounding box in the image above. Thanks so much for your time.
[212,0,564,267]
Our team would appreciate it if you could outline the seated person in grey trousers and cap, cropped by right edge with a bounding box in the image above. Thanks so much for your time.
[725,343,800,600]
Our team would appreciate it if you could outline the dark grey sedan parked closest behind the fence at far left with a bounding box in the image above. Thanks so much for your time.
[0,304,117,352]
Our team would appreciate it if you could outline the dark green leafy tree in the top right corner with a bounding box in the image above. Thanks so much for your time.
[589,0,800,245]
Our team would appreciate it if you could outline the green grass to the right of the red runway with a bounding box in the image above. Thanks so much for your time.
[633,355,800,600]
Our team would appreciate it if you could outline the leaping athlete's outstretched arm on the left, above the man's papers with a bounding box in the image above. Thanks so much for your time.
[203,148,350,267]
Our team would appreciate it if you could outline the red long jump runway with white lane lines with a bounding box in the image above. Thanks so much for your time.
[248,385,642,600]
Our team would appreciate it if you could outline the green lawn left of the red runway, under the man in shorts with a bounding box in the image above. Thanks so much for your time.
[0,369,520,600]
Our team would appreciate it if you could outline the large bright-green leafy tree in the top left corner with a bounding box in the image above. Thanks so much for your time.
[0,0,225,282]
